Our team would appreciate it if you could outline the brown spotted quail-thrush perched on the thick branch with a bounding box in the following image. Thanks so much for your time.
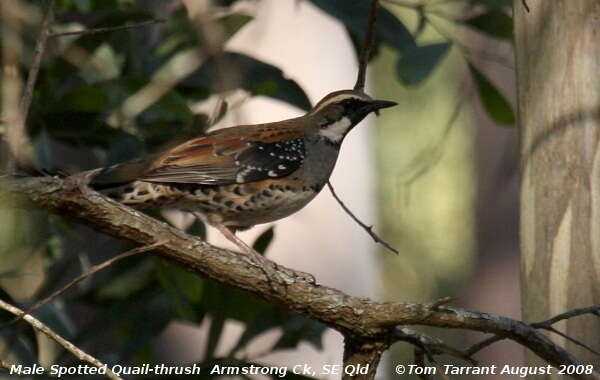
[90,90,397,278]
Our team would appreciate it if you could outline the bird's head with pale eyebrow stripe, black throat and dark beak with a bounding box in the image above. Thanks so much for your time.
[309,90,397,144]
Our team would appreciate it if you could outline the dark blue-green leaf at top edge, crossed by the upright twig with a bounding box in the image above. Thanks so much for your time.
[310,0,416,53]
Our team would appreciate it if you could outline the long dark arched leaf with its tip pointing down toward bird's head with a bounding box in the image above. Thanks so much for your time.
[184,52,311,110]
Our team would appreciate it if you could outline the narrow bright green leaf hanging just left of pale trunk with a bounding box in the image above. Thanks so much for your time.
[469,64,515,126]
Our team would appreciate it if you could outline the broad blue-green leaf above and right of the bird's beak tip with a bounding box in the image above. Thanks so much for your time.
[396,42,451,86]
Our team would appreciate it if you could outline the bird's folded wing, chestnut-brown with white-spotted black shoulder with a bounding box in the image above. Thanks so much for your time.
[140,119,305,185]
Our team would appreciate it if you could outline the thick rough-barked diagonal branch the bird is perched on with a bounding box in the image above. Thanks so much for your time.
[0,172,600,379]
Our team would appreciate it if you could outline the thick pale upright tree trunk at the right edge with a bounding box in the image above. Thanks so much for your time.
[514,0,600,374]
